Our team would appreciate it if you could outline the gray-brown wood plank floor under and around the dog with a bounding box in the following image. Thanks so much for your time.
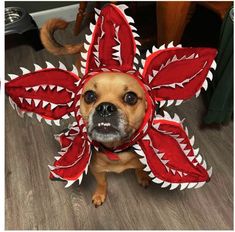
[5,20,233,230]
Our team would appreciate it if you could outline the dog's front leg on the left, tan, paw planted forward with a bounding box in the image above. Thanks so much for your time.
[91,169,107,207]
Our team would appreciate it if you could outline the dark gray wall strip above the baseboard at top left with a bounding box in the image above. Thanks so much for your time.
[5,1,79,13]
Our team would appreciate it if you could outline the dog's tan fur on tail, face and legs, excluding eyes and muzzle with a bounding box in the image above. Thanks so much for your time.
[41,19,150,207]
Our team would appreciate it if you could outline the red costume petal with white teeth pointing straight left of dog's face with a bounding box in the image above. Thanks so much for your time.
[6,62,80,124]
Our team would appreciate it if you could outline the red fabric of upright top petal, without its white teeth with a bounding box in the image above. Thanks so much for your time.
[86,4,136,72]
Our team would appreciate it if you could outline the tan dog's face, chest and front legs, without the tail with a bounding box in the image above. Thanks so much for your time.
[80,72,150,206]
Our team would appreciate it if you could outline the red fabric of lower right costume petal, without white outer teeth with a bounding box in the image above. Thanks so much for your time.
[139,119,209,183]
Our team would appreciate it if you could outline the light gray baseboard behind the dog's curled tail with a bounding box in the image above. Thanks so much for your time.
[30,4,79,28]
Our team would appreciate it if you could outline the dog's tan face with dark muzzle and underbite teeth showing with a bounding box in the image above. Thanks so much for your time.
[80,72,147,147]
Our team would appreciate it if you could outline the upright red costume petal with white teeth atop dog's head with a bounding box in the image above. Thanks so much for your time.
[81,4,140,74]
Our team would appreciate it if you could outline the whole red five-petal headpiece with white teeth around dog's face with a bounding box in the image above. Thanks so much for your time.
[6,4,217,189]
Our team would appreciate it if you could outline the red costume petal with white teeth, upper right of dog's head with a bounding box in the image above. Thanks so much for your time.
[142,44,217,105]
